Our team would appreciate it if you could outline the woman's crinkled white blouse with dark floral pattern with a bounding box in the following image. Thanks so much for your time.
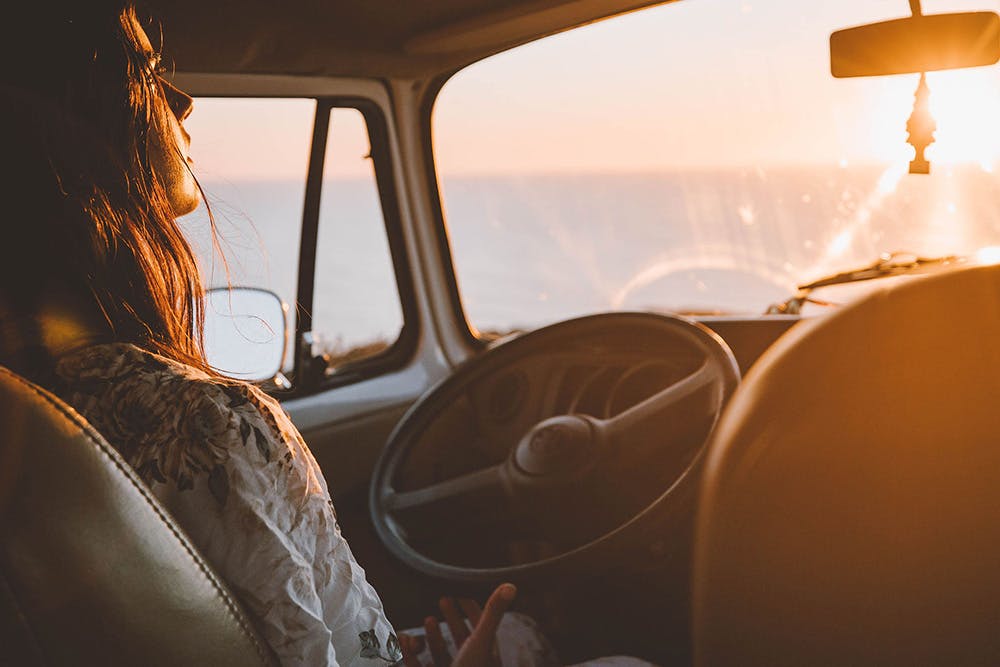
[54,343,402,667]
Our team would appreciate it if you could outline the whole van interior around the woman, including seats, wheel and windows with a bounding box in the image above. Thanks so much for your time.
[0,0,1000,665]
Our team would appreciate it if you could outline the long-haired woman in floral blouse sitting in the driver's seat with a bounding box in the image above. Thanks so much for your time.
[0,0,513,665]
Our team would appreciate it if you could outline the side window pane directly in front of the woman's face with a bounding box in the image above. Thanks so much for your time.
[180,98,316,370]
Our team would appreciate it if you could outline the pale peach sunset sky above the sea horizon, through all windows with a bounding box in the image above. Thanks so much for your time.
[188,0,1000,180]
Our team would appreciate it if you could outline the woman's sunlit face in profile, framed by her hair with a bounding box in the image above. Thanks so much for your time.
[133,14,201,216]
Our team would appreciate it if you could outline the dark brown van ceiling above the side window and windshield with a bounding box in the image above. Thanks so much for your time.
[150,0,673,78]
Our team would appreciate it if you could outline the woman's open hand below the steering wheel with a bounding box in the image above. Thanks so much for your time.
[400,584,517,667]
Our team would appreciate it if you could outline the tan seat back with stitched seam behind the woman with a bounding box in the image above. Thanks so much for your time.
[0,369,272,666]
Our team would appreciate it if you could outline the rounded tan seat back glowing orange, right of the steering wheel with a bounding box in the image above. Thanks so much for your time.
[693,267,1000,666]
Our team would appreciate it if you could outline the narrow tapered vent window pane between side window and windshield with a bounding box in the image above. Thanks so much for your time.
[313,108,403,368]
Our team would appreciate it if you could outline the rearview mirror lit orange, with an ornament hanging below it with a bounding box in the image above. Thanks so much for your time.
[830,12,1000,78]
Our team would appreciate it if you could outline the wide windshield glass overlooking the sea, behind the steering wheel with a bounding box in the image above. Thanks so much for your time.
[433,0,1000,332]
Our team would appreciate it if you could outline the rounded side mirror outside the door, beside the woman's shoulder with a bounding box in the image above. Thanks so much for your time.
[205,287,288,388]
